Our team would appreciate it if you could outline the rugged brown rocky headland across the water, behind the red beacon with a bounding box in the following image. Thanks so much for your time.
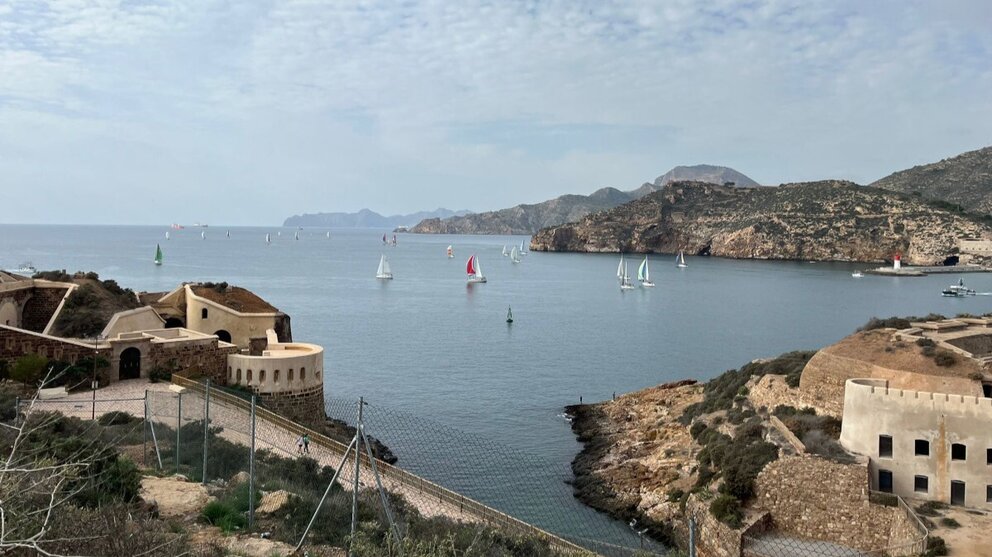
[531,181,992,265]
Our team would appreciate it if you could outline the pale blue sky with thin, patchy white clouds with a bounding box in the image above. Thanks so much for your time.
[0,0,992,226]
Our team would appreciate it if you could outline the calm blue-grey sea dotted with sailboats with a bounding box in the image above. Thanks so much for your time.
[0,225,992,543]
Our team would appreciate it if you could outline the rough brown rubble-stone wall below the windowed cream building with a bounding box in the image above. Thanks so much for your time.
[753,455,919,551]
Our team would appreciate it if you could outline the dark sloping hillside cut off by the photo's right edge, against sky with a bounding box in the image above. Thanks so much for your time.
[871,147,992,215]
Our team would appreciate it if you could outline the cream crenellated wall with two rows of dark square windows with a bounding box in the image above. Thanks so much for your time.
[840,379,992,510]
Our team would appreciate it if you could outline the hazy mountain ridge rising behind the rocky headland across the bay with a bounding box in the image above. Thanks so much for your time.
[410,164,758,234]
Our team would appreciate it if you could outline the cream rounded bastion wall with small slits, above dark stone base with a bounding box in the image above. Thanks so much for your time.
[227,343,324,394]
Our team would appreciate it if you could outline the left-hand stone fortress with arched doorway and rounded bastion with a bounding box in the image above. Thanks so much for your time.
[0,272,324,423]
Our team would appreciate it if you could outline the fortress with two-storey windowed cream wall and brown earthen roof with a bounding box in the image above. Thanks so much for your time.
[752,317,992,510]
